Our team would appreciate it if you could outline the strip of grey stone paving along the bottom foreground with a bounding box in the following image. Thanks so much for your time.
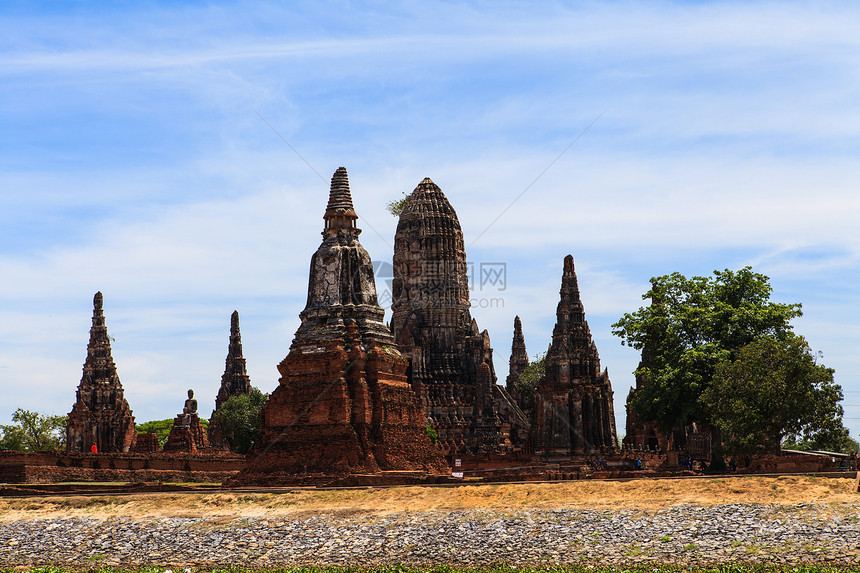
[0,504,860,568]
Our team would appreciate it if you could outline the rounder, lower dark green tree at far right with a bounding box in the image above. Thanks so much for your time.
[702,336,848,453]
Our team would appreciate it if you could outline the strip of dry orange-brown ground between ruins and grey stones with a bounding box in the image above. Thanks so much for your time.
[0,476,860,522]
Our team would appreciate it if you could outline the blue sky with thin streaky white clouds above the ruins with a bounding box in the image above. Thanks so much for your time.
[0,2,860,437]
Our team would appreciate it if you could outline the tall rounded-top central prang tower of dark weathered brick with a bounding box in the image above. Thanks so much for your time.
[391,179,528,453]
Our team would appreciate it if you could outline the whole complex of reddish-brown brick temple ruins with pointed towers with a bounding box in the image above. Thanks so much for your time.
[10,167,836,486]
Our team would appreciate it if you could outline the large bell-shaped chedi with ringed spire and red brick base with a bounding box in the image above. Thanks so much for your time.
[236,167,447,484]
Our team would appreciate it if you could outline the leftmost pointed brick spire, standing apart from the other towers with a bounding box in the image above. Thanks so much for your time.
[66,292,136,453]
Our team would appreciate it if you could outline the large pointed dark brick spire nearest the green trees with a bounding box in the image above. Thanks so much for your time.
[532,255,618,457]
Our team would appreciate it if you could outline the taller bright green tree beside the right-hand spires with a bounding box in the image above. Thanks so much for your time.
[612,267,801,432]
